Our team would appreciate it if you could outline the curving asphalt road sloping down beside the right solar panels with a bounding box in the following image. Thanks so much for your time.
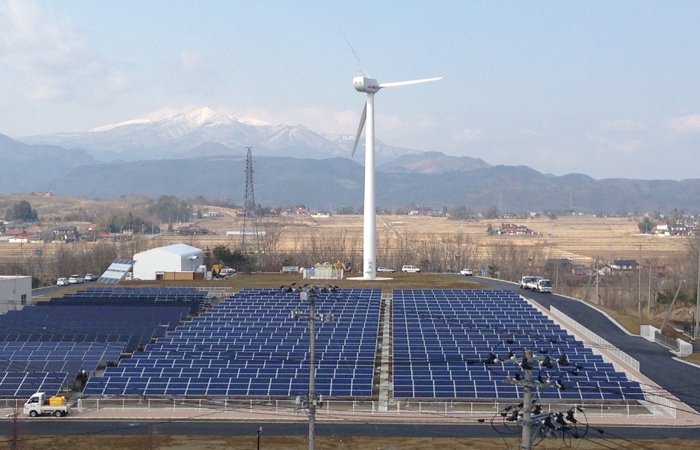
[470,277,700,413]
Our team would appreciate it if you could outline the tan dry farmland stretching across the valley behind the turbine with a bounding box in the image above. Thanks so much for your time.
[0,196,688,272]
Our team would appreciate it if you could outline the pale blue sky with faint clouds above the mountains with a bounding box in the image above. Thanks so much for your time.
[0,0,700,179]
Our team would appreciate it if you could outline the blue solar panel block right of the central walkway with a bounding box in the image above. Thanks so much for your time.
[393,290,644,400]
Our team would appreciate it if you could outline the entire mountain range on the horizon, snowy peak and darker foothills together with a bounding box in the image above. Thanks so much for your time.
[0,108,700,213]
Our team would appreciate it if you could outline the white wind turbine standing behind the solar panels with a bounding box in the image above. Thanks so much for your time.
[351,75,441,280]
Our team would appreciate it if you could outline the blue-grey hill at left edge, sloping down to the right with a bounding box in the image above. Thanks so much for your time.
[0,134,95,193]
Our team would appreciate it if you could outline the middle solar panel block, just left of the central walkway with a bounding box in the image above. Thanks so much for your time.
[84,289,381,397]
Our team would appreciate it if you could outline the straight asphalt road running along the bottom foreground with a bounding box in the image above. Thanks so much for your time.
[0,417,700,440]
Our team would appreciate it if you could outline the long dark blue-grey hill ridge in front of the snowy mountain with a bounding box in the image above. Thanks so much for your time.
[38,155,700,213]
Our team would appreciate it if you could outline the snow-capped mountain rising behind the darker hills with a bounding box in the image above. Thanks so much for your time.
[20,107,420,163]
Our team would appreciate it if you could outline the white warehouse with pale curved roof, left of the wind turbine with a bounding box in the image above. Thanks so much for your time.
[134,244,204,280]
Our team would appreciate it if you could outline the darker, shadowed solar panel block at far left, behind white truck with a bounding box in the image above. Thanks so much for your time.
[0,288,207,397]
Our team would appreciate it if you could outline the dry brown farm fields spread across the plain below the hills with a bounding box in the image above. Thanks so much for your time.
[0,195,687,265]
